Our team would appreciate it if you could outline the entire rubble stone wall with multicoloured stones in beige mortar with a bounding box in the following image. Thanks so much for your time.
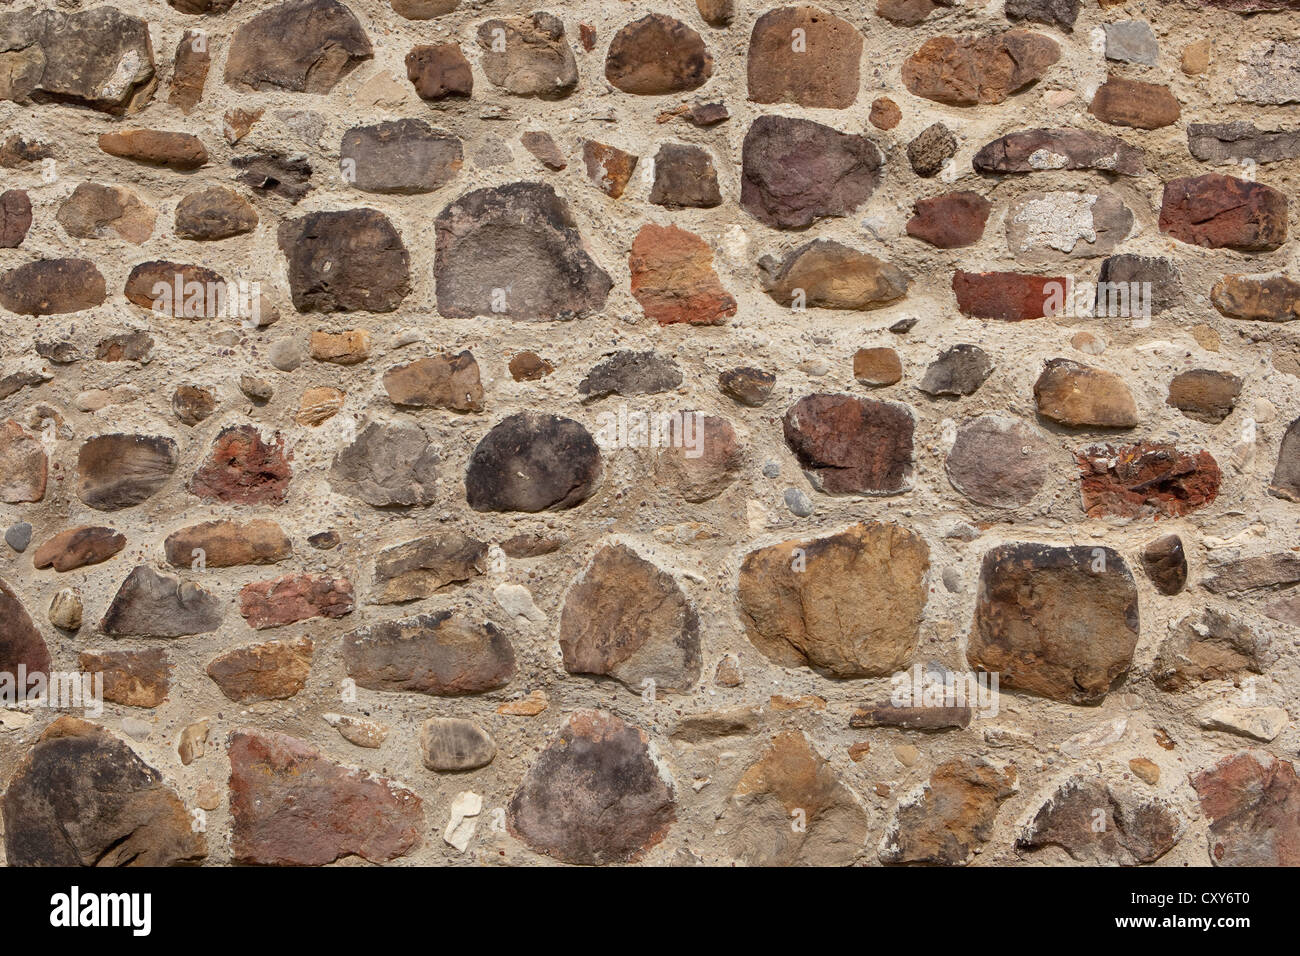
[0,0,1300,866]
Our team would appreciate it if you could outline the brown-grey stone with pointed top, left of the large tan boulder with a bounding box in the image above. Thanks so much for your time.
[559,544,701,693]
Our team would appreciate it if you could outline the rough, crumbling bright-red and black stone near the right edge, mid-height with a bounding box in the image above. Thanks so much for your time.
[1075,442,1222,518]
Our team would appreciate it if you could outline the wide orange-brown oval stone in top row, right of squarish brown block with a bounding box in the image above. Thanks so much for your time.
[902,30,1061,107]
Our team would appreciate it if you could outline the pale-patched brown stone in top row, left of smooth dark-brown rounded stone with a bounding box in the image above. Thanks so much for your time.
[477,13,577,100]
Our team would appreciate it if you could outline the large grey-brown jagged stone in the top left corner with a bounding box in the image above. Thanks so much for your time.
[0,7,155,116]
